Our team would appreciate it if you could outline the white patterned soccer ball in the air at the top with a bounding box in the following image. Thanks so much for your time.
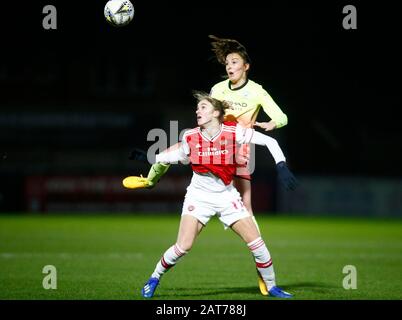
[104,0,134,27]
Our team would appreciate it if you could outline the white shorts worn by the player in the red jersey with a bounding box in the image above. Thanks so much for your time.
[182,185,251,229]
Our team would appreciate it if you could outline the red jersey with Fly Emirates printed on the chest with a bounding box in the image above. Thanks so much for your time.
[183,121,238,185]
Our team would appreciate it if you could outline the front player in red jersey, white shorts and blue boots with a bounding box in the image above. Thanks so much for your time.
[133,93,296,298]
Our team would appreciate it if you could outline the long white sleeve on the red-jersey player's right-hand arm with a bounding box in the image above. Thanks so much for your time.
[236,125,286,163]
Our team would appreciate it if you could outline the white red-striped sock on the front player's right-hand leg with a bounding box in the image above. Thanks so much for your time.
[247,237,275,291]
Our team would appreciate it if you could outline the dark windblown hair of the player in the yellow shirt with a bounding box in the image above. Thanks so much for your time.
[208,35,251,65]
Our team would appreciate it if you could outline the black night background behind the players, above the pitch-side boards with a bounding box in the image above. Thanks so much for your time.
[0,0,402,212]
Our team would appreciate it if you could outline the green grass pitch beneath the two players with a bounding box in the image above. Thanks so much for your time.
[0,215,402,300]
